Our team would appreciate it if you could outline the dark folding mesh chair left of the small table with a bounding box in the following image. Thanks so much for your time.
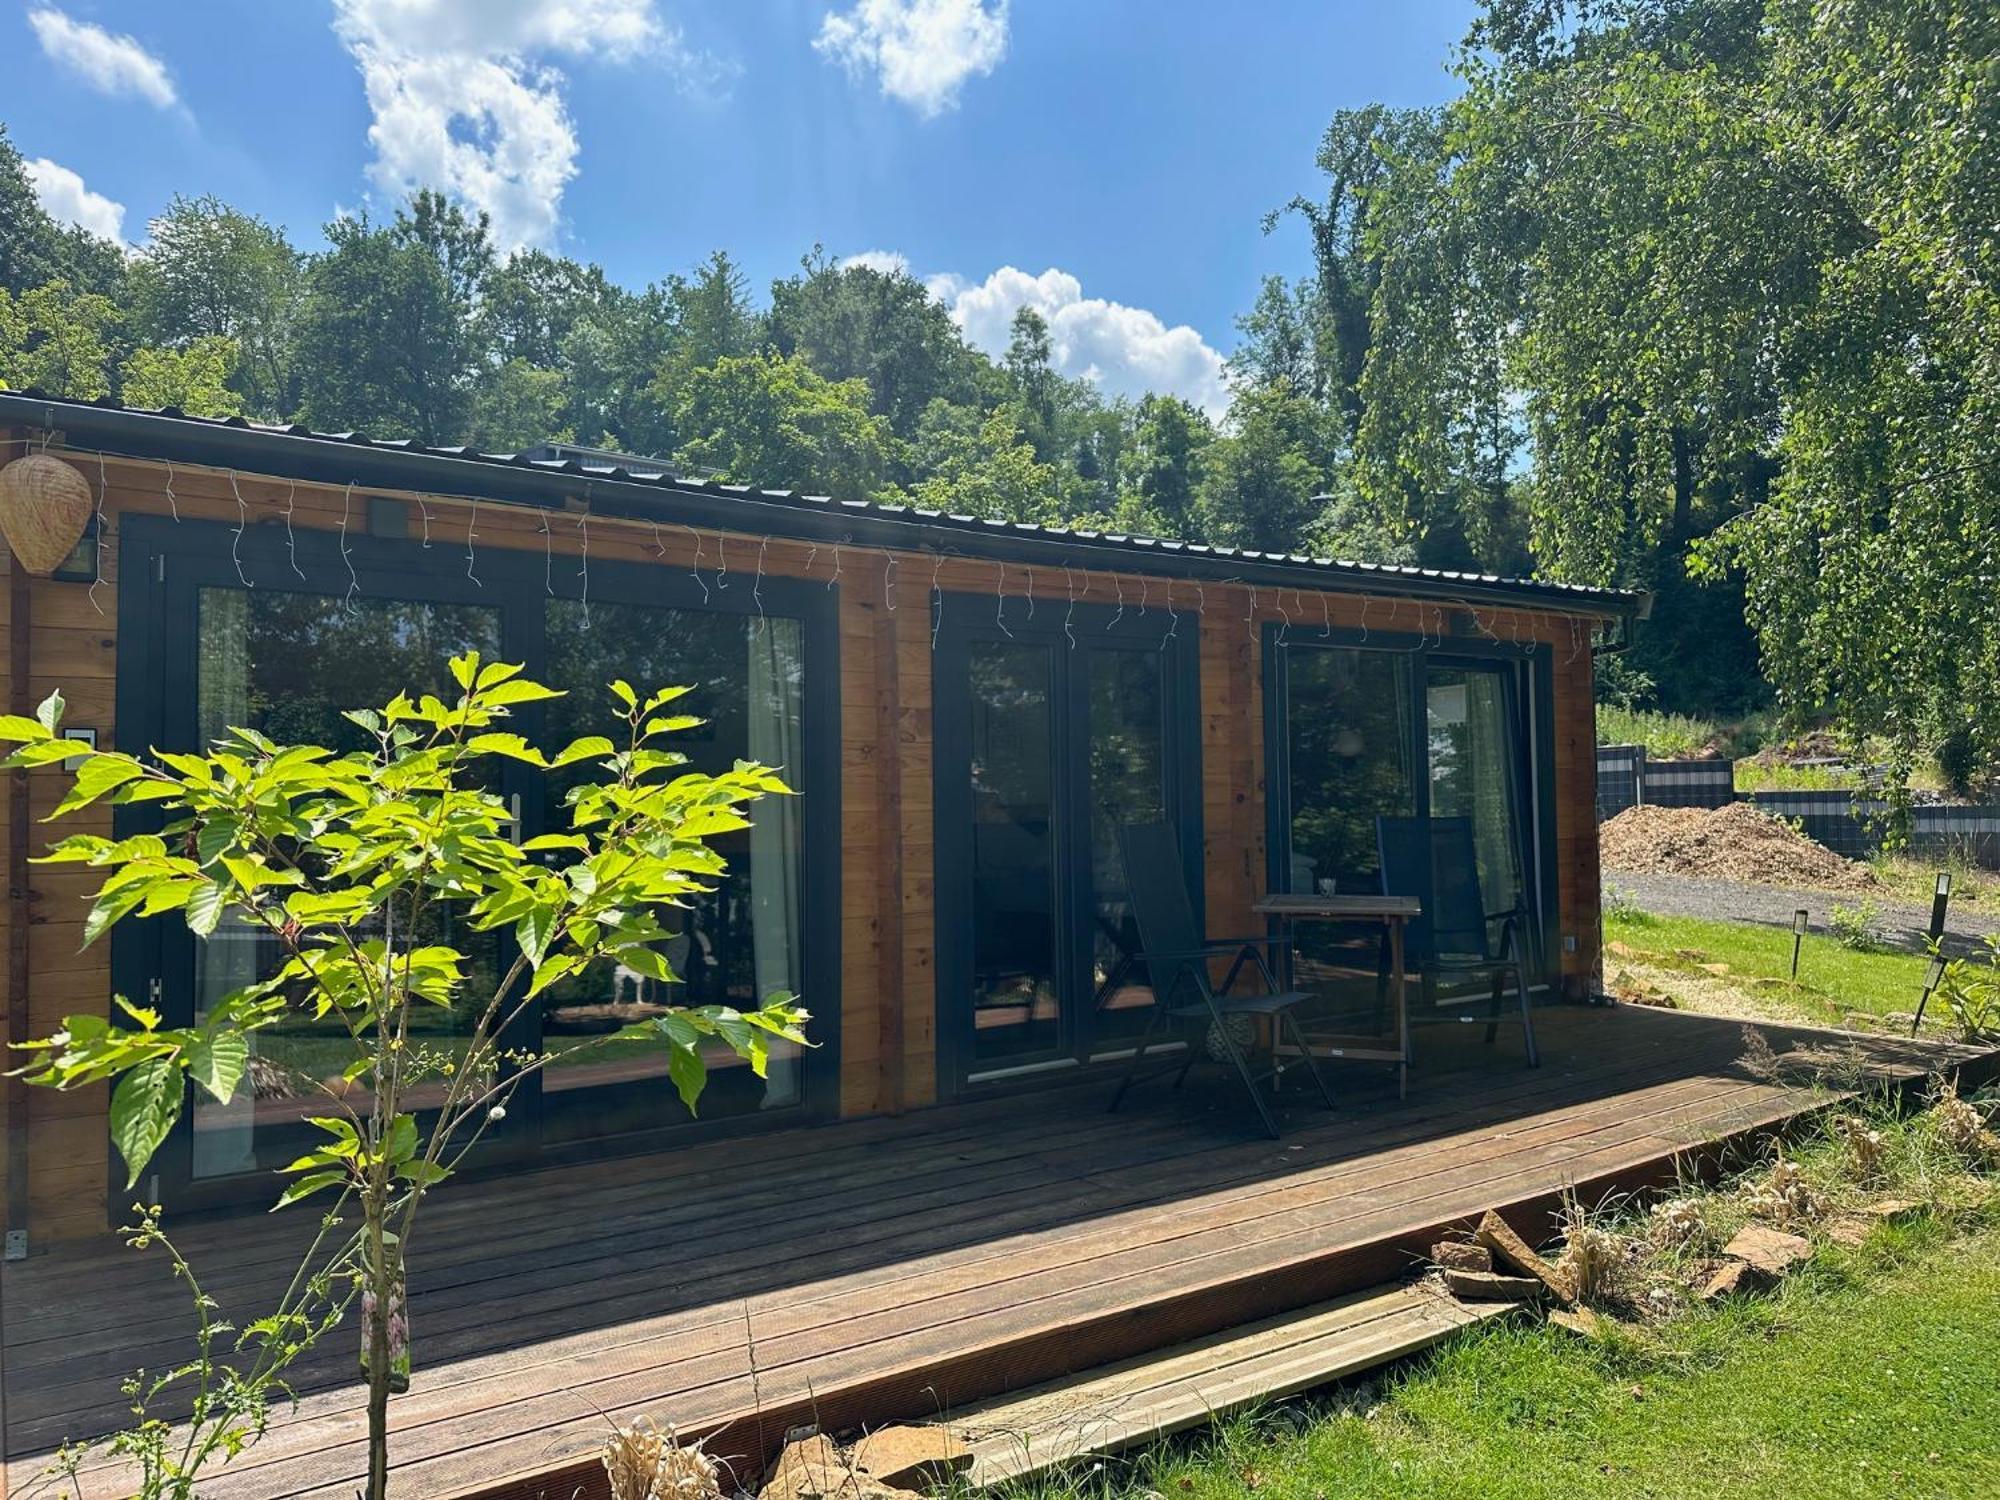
[1112,822,1334,1138]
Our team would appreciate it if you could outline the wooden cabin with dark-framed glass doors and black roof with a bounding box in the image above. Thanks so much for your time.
[0,394,1636,1252]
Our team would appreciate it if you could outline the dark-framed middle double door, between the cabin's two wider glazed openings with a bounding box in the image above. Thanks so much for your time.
[934,596,1198,1094]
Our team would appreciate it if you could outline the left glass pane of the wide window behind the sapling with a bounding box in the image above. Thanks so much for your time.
[192,588,500,1178]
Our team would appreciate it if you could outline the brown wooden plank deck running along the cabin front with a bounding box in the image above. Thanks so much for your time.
[0,1008,1988,1500]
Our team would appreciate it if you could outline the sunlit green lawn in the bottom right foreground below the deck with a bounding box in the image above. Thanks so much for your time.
[1056,1222,2000,1500]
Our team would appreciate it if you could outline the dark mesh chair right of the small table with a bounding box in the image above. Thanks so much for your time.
[1376,818,1542,1068]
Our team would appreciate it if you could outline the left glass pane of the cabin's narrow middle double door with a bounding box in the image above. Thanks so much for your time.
[966,640,1064,1070]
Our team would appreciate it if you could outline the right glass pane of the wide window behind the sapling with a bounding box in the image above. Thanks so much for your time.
[540,598,804,1142]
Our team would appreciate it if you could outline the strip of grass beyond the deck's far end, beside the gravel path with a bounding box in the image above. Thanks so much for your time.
[1604,912,1950,1030]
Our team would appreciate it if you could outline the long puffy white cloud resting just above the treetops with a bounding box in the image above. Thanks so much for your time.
[926,266,1230,420]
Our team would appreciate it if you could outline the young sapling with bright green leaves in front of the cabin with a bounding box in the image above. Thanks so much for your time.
[0,654,808,1500]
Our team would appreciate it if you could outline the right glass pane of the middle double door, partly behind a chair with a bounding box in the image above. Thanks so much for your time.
[1084,648,1168,1050]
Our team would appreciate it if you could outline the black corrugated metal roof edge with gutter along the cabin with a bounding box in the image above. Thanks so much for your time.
[0,390,1646,616]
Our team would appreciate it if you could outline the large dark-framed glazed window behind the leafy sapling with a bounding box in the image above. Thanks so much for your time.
[114,518,840,1200]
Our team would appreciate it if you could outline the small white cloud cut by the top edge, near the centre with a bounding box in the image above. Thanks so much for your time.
[812,0,1008,118]
